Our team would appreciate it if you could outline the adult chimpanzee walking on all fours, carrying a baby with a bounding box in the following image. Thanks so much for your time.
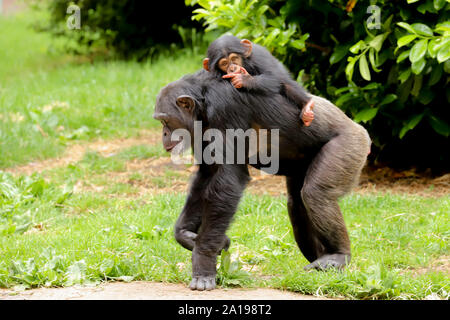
[154,71,370,290]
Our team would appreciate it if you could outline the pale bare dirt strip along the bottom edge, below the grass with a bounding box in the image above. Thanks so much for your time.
[0,281,326,300]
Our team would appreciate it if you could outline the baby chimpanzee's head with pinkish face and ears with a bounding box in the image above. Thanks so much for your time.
[203,35,252,75]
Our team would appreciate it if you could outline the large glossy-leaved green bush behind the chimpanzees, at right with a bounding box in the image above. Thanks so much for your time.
[186,0,450,168]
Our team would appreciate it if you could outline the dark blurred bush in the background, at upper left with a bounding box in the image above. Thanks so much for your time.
[41,0,199,58]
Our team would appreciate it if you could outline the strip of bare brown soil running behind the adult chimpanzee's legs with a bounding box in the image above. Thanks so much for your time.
[80,157,450,197]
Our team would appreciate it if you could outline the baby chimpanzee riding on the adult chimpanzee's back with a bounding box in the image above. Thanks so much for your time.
[203,35,314,126]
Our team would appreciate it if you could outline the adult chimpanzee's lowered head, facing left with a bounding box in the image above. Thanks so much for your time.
[153,77,199,152]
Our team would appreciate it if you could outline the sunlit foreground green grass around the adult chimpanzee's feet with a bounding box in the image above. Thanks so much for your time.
[0,170,450,299]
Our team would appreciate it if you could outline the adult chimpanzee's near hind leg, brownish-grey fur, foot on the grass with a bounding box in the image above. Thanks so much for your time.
[301,130,369,270]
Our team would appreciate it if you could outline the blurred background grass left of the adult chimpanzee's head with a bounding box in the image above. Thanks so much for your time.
[0,13,201,168]
